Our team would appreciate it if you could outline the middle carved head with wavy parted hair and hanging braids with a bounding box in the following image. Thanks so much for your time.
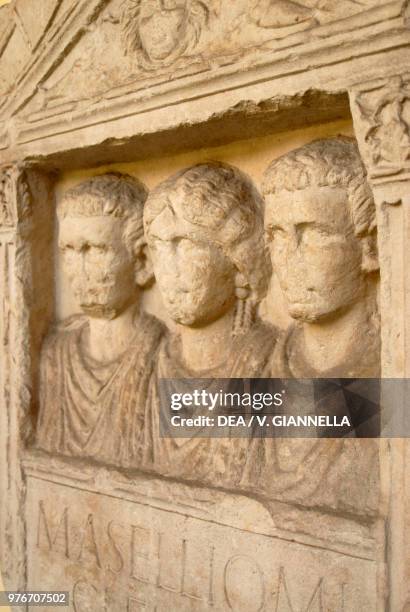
[144,162,271,328]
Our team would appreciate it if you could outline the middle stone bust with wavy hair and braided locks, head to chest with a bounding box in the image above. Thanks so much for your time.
[144,162,276,484]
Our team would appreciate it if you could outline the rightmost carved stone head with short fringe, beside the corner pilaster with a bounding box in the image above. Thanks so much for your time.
[263,137,378,321]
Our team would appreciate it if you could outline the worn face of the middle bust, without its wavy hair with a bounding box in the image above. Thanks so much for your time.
[147,196,236,327]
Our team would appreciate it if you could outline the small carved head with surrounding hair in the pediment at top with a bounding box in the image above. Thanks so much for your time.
[122,0,209,70]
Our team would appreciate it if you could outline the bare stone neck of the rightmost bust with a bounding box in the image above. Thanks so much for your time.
[301,283,378,376]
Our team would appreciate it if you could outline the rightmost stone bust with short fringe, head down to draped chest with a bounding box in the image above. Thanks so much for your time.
[261,137,380,517]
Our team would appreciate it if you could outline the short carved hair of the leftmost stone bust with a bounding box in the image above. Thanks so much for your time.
[57,172,148,268]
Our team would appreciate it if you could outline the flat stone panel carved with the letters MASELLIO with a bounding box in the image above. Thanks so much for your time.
[29,492,373,612]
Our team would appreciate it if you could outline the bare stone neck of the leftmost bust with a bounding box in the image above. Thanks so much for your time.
[83,304,136,362]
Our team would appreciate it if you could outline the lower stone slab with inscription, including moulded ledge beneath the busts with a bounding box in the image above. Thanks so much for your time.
[26,456,377,612]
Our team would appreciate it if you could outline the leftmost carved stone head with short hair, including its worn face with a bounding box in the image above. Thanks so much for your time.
[57,172,152,318]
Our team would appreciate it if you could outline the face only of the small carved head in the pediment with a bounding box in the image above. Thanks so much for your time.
[139,0,185,60]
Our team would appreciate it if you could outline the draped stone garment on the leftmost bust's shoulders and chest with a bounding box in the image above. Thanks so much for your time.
[36,313,163,467]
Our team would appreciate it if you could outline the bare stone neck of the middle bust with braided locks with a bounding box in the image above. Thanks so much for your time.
[178,308,235,373]
